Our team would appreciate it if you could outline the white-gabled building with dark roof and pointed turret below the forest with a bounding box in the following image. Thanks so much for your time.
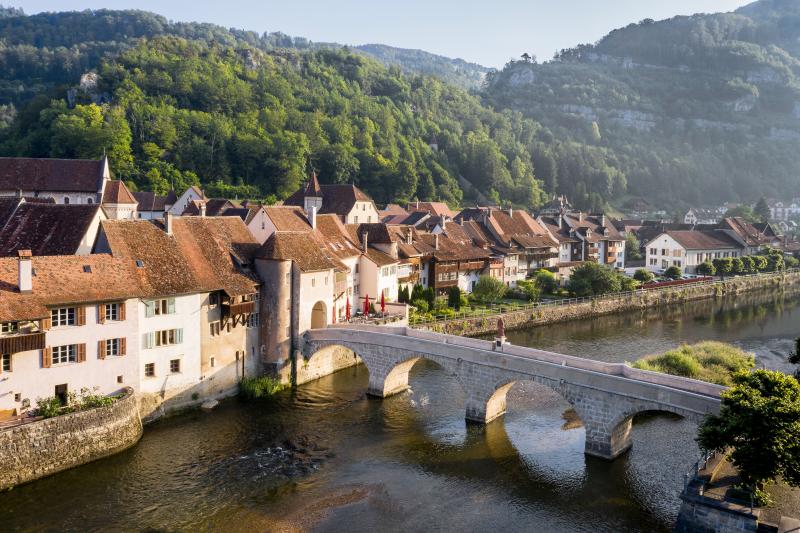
[283,174,380,224]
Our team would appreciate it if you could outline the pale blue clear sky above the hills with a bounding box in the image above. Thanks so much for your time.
[18,0,750,67]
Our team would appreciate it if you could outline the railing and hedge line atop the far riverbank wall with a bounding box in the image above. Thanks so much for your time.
[408,268,800,326]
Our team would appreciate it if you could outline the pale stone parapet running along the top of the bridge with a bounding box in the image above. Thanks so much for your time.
[316,324,725,398]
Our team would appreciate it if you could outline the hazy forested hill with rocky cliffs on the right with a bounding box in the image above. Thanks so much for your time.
[485,0,800,212]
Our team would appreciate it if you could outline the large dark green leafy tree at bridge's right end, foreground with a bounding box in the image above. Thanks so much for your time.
[697,370,800,504]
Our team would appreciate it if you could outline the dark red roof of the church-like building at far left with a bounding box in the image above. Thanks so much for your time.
[0,157,105,194]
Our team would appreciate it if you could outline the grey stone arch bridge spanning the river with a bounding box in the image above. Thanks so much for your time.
[303,325,724,459]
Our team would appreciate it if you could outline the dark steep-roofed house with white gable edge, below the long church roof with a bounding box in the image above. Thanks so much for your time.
[0,197,107,257]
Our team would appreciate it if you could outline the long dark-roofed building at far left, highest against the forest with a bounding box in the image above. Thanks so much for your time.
[0,157,111,204]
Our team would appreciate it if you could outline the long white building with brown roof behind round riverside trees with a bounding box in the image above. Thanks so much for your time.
[645,230,744,274]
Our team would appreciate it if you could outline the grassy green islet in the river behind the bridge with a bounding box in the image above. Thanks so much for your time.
[630,341,755,386]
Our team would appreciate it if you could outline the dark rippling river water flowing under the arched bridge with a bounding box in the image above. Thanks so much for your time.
[0,288,800,532]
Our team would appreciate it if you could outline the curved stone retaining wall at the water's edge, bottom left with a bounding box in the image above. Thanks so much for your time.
[0,389,142,490]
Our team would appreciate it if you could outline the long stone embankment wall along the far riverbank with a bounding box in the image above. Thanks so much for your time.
[414,271,800,336]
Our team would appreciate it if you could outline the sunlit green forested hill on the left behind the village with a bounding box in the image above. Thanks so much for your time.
[0,11,547,208]
